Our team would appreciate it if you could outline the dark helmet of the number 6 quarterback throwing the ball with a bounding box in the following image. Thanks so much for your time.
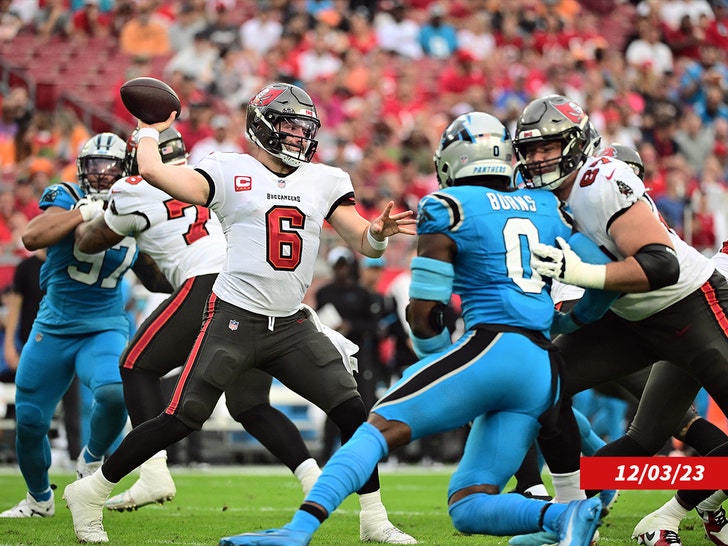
[245,83,321,167]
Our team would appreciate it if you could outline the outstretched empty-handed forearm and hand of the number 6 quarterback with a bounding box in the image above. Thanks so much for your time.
[329,201,417,258]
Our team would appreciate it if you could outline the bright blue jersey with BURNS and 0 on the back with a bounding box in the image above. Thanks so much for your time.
[417,186,572,337]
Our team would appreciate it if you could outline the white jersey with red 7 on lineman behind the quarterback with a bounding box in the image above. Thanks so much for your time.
[104,176,226,290]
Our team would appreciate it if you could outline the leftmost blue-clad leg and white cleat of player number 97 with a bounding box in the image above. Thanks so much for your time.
[0,328,73,517]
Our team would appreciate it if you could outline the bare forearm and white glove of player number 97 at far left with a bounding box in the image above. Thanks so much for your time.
[22,204,103,250]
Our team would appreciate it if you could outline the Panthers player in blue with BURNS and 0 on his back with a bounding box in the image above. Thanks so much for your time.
[215,112,601,546]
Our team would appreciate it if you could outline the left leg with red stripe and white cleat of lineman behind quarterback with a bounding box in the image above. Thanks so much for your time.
[106,275,217,510]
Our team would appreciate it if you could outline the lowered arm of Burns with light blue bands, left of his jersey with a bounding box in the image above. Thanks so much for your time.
[407,233,457,358]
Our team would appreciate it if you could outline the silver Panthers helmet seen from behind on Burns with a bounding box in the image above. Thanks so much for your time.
[432,112,513,189]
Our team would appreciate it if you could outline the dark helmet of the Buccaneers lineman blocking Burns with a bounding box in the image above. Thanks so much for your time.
[513,95,601,190]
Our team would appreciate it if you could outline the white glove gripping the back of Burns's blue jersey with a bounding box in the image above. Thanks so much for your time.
[531,237,607,290]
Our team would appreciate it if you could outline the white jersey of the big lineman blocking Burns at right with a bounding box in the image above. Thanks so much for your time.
[567,157,715,321]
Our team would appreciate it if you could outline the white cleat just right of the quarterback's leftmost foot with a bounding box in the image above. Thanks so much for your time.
[106,458,177,511]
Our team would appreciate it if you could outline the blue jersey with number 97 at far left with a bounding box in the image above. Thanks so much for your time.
[35,183,137,335]
